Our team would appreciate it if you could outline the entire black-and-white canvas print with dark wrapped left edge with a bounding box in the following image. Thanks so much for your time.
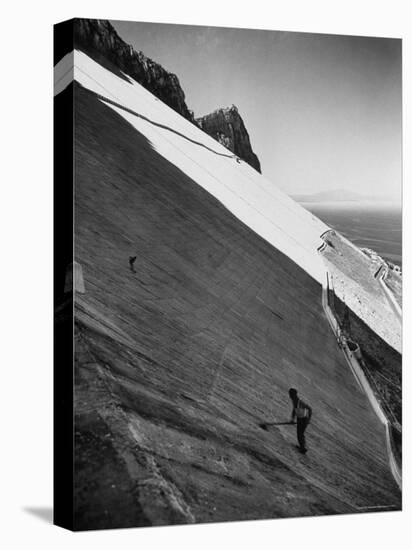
[54,19,402,530]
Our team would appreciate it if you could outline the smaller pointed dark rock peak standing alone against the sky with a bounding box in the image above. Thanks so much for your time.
[196,105,261,172]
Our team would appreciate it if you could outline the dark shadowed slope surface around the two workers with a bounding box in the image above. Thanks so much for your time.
[75,85,400,528]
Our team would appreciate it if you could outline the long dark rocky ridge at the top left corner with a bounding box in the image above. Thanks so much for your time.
[74,19,194,122]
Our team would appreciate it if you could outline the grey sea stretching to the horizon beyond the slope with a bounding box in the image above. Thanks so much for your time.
[301,205,402,267]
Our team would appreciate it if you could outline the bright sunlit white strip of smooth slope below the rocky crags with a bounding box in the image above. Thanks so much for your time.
[67,51,328,281]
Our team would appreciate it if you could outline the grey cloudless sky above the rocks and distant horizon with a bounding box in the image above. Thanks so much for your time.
[112,21,402,203]
